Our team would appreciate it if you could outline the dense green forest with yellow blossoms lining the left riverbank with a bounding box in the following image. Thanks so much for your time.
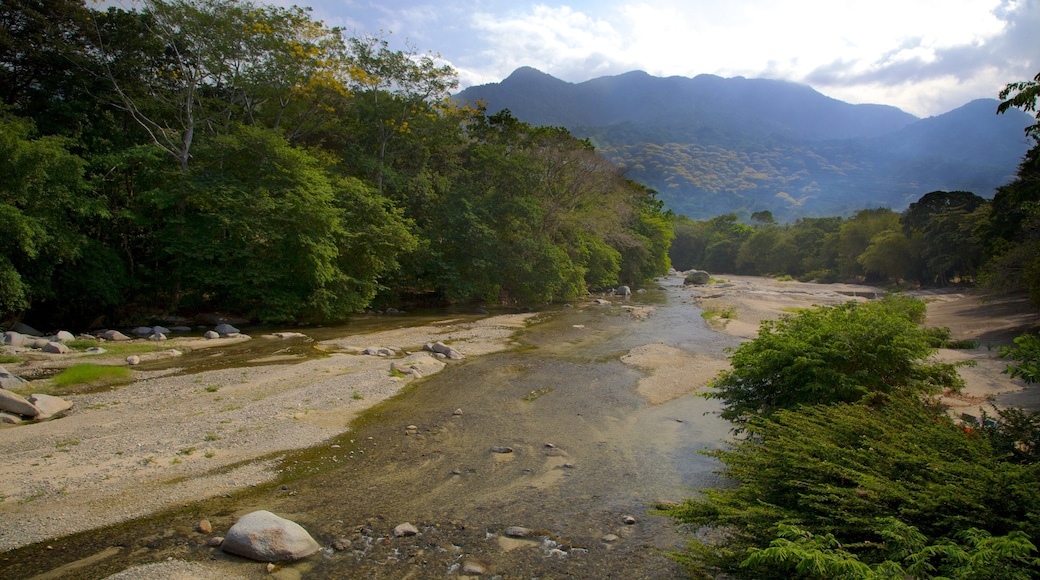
[0,0,672,328]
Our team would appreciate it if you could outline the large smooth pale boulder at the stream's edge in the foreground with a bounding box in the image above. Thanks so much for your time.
[220,509,321,562]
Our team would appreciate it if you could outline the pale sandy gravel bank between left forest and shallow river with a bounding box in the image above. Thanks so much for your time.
[0,314,537,552]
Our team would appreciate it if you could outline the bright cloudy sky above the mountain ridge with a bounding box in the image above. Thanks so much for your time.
[277,0,1040,116]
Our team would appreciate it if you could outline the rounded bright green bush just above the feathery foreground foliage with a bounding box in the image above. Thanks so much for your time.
[707,296,961,423]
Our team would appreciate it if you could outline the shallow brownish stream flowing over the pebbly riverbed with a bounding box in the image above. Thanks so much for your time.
[6,279,738,579]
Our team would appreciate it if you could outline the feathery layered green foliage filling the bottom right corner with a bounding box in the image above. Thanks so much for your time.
[668,396,1040,579]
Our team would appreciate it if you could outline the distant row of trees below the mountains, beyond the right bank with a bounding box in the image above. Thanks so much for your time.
[669,138,1040,297]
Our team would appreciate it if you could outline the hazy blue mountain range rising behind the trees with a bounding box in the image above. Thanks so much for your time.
[456,67,1033,220]
